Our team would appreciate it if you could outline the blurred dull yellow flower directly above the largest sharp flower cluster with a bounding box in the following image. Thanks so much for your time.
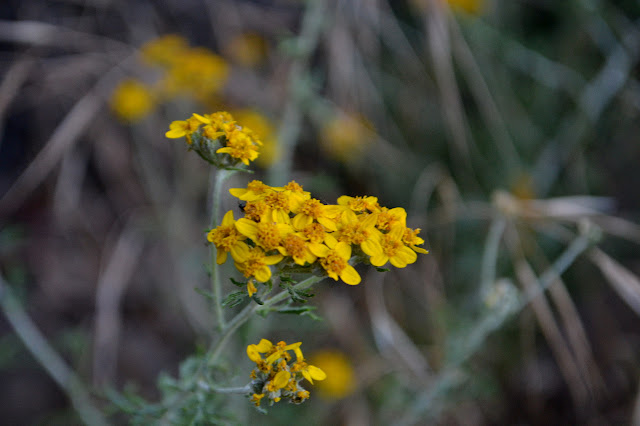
[320,114,373,163]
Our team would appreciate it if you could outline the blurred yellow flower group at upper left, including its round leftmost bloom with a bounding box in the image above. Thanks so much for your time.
[111,34,229,122]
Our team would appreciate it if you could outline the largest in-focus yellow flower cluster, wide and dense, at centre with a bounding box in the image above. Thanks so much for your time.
[207,180,427,288]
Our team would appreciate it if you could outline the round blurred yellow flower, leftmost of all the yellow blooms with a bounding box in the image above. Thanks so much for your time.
[110,79,155,122]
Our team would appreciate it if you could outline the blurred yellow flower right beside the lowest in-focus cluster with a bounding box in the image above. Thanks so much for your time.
[310,350,356,399]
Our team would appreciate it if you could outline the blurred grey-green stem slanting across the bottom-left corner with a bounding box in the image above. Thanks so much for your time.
[0,276,108,426]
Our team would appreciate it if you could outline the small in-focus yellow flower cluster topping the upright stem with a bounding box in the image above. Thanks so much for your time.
[165,111,262,169]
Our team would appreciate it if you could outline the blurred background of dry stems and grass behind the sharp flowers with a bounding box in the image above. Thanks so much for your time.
[0,0,640,425]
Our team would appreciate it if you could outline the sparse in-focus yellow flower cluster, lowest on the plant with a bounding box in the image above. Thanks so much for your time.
[247,339,327,407]
